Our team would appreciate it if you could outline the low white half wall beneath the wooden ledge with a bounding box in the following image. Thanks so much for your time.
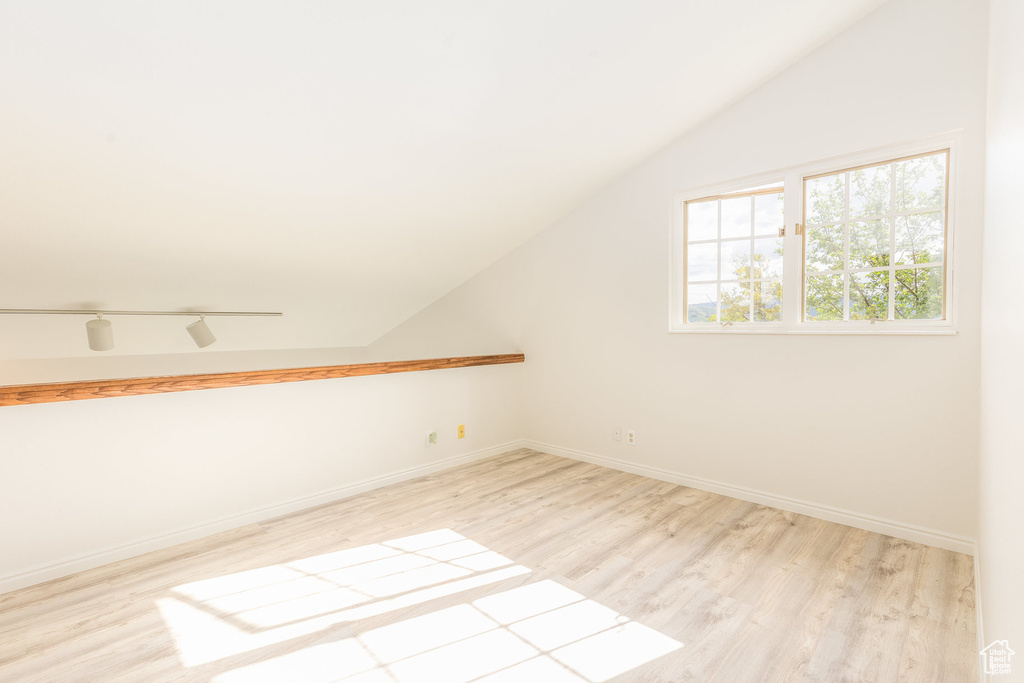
[0,365,523,593]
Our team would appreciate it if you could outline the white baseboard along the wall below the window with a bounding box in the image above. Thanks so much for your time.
[524,440,976,555]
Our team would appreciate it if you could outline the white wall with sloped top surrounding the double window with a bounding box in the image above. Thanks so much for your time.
[371,0,987,539]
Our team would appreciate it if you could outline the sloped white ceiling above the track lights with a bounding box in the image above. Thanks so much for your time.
[0,0,882,357]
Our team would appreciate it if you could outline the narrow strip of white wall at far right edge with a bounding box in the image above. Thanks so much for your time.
[980,0,1024,663]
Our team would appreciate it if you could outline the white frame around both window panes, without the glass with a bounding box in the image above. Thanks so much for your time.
[669,131,962,335]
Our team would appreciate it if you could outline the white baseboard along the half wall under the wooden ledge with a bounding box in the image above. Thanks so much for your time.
[0,441,525,595]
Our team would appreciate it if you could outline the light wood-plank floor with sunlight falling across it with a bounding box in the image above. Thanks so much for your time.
[0,450,977,683]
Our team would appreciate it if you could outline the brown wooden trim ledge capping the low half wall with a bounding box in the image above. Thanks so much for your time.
[0,353,526,405]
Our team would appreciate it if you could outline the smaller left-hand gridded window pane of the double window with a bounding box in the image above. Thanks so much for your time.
[683,185,784,325]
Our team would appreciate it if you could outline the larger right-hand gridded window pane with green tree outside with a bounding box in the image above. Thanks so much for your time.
[802,150,949,323]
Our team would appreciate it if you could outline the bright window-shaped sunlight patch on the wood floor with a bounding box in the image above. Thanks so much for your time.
[158,529,682,683]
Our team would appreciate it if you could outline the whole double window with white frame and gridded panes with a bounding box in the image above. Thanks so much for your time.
[670,138,956,334]
